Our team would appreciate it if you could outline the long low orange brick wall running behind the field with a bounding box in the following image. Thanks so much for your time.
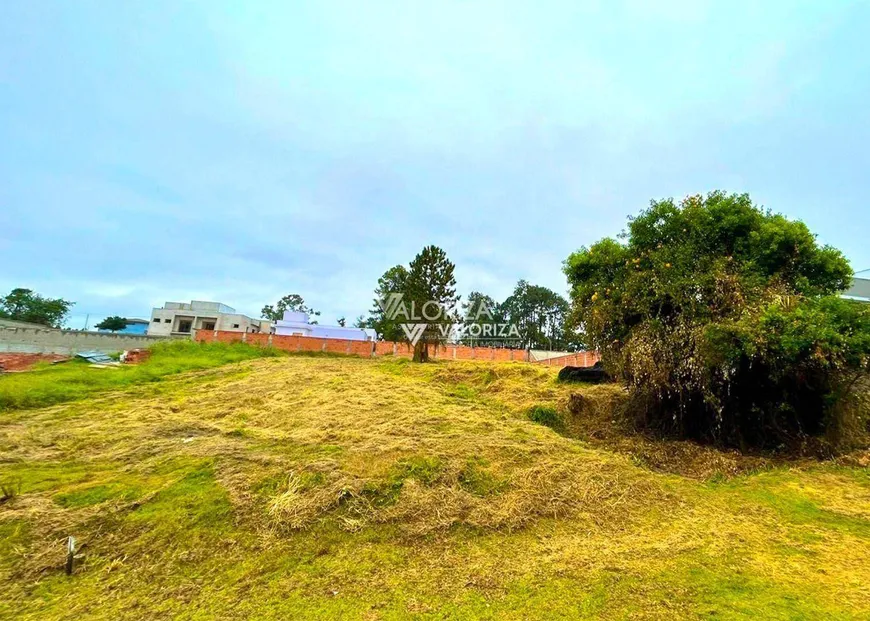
[196,330,598,368]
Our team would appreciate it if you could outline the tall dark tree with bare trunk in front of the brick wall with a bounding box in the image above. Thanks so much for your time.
[405,246,459,362]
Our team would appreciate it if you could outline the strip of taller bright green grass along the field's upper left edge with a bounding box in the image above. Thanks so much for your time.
[0,341,284,410]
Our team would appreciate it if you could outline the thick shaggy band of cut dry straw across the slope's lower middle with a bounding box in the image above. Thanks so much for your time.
[267,452,664,535]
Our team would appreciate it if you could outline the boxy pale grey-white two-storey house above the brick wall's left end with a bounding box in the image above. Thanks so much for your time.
[148,300,272,336]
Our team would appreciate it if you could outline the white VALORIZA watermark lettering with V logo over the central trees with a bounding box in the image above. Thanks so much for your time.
[377,293,522,347]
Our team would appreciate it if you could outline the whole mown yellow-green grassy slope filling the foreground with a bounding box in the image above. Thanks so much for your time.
[0,357,870,619]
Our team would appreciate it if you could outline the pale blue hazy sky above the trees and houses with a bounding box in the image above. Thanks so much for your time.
[0,0,870,327]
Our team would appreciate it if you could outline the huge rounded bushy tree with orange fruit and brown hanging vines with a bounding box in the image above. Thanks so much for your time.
[565,192,870,447]
